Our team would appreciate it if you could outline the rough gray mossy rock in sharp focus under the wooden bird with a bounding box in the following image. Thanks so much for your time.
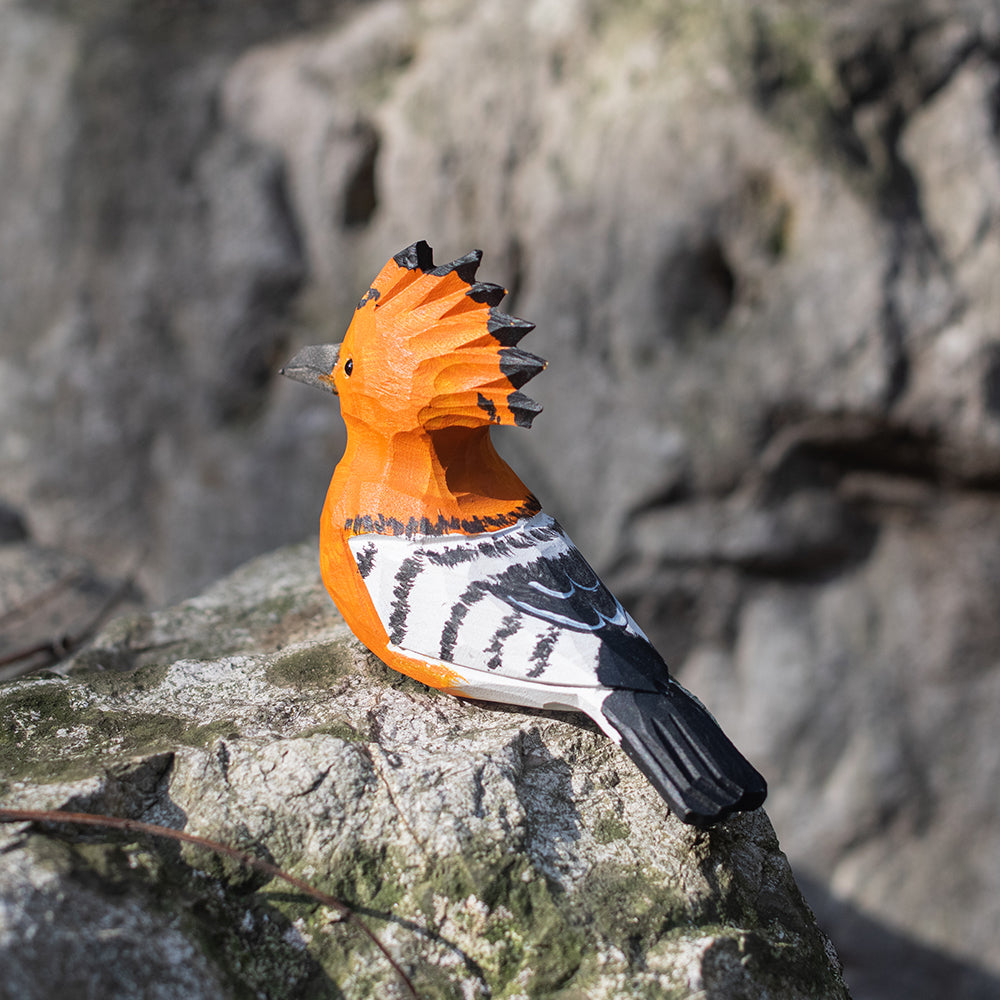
[0,546,847,1000]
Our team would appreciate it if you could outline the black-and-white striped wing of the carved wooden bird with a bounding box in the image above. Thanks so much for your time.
[350,513,666,687]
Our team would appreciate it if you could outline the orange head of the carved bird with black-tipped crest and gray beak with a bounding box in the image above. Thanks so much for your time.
[282,240,545,434]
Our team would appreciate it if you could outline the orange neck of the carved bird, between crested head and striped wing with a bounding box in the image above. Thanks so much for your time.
[324,421,539,534]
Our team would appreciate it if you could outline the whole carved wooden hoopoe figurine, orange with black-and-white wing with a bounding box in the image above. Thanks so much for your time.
[282,241,766,826]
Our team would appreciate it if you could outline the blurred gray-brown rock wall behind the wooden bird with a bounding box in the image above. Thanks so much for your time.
[0,0,1000,1000]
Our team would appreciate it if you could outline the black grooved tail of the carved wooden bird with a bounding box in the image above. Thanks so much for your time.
[601,682,767,826]
